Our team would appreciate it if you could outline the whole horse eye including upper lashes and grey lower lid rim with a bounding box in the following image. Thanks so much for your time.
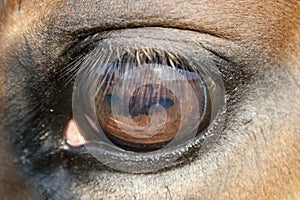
[73,36,224,173]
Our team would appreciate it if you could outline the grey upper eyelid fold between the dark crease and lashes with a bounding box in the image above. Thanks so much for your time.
[59,27,232,65]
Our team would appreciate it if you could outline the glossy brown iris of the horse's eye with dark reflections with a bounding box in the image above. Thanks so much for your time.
[95,64,208,151]
